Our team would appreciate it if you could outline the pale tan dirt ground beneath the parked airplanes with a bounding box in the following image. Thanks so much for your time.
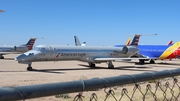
[0,54,180,101]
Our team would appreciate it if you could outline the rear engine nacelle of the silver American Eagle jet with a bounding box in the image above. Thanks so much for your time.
[122,46,139,55]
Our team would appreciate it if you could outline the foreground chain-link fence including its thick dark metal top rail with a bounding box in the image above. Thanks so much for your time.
[0,69,180,101]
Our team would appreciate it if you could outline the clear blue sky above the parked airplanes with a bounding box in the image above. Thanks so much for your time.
[0,0,180,46]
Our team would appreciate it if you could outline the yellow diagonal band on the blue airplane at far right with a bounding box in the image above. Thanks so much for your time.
[159,42,180,59]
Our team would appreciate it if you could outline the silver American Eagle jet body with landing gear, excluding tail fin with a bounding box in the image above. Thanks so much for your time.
[15,45,139,71]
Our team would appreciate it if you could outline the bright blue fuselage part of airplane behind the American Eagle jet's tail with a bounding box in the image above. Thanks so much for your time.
[115,45,171,58]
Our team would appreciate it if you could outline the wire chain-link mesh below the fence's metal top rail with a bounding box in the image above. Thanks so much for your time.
[70,77,180,101]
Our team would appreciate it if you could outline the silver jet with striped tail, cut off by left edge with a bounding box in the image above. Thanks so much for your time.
[0,38,36,59]
